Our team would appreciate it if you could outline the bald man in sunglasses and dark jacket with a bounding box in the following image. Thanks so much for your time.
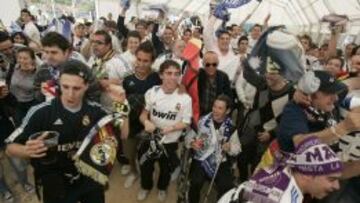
[198,51,232,116]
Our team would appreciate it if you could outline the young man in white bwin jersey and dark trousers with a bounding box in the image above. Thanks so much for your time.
[137,60,192,201]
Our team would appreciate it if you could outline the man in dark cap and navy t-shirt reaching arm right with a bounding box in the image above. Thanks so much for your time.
[276,71,360,152]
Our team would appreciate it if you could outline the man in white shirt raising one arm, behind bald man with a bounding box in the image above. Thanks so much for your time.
[204,16,239,81]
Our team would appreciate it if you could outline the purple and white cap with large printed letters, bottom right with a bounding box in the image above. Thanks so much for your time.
[286,136,343,175]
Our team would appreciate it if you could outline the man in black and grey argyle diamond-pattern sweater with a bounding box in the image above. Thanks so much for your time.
[238,57,295,182]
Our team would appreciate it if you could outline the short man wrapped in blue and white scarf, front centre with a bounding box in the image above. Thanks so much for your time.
[185,94,241,203]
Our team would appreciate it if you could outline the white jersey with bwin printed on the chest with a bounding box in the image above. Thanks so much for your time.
[145,86,192,144]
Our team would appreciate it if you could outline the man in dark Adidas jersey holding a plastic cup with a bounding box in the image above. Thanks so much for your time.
[6,60,106,203]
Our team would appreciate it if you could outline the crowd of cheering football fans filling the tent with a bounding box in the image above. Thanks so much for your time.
[0,2,360,203]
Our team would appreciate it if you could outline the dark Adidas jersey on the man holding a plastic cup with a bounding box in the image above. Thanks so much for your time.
[9,98,106,176]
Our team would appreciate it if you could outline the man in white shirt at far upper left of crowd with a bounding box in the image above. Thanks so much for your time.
[21,9,40,43]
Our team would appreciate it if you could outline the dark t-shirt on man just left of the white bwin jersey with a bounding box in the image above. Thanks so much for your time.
[123,72,161,137]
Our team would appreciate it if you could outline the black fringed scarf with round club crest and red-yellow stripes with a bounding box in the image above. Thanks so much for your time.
[73,114,122,185]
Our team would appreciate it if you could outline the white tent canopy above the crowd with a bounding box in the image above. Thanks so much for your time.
[97,0,360,40]
